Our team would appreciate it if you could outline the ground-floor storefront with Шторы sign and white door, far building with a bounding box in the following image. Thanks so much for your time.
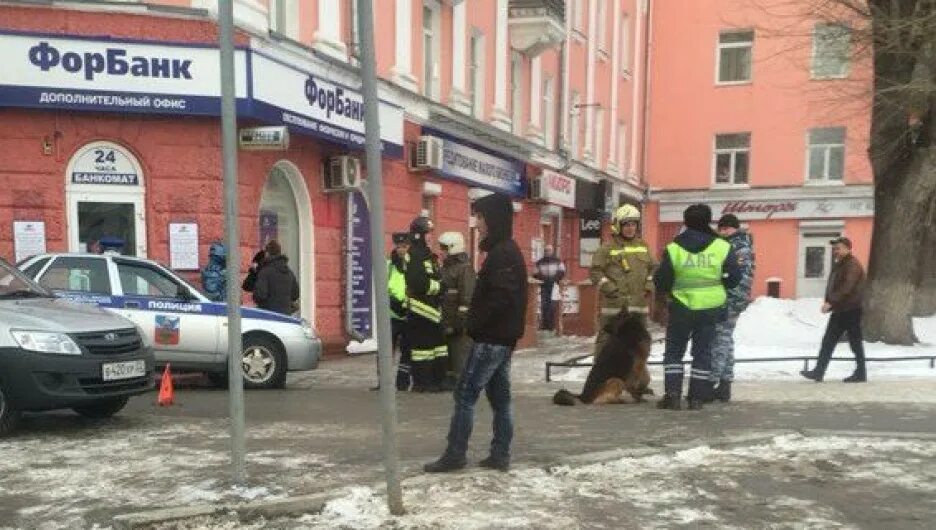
[654,185,874,298]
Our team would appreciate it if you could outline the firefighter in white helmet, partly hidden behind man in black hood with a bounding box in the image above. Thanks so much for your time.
[439,232,475,391]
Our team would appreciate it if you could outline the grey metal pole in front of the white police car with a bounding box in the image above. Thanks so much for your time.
[218,0,247,485]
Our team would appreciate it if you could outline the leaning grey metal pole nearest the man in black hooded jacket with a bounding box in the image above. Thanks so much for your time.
[358,0,404,515]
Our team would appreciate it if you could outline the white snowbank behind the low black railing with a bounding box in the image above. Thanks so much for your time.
[540,298,936,382]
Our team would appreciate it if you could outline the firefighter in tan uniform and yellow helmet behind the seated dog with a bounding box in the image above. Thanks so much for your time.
[589,204,656,355]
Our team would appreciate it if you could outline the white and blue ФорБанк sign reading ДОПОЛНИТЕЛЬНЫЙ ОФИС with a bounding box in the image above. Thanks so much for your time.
[0,33,247,116]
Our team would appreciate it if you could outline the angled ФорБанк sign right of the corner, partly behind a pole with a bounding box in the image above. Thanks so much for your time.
[250,51,403,157]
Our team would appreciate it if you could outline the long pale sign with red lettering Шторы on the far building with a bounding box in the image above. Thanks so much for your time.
[660,197,874,222]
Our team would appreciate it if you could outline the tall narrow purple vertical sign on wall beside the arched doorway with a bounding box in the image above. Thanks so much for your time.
[345,192,374,341]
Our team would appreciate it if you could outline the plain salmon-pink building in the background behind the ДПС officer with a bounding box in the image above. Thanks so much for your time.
[645,0,874,297]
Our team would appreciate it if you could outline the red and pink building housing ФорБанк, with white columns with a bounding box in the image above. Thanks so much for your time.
[0,0,649,351]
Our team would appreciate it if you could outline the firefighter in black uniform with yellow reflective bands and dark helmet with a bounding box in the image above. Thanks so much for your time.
[405,217,448,392]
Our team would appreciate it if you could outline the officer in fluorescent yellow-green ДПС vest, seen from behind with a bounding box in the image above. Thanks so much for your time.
[654,204,741,410]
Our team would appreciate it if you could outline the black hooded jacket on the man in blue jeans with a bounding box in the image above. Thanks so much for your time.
[468,194,527,348]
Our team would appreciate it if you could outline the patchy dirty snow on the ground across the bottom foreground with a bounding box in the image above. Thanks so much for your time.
[162,435,936,529]
